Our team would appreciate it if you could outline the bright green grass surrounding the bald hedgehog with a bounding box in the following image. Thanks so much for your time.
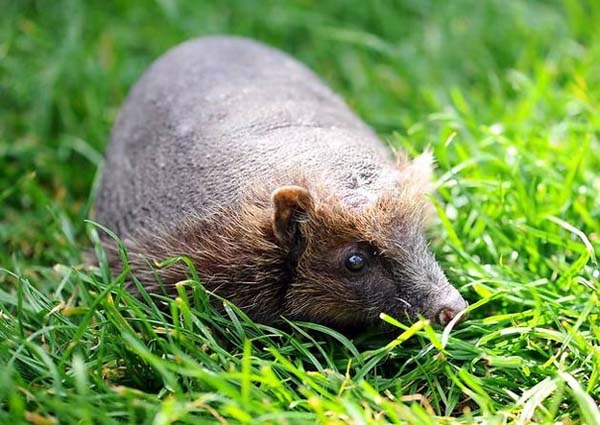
[0,0,600,424]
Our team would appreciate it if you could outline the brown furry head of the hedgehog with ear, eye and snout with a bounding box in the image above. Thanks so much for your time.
[273,152,466,327]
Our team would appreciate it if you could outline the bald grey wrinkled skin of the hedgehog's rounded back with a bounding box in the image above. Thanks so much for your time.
[96,37,395,236]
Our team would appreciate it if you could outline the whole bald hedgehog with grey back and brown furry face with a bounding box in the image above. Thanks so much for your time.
[95,37,466,329]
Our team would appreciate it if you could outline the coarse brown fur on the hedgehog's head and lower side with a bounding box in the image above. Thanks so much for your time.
[105,169,436,328]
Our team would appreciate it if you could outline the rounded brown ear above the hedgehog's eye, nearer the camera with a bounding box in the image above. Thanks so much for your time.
[271,186,313,249]
